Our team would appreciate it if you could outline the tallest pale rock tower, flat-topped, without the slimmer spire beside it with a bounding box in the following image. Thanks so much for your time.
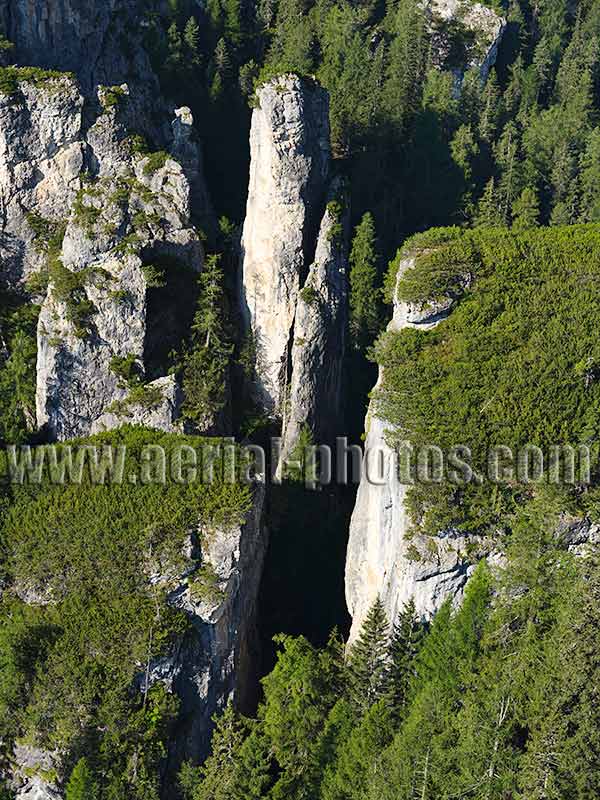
[242,75,330,418]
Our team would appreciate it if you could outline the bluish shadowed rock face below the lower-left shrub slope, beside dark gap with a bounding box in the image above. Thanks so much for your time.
[140,484,267,764]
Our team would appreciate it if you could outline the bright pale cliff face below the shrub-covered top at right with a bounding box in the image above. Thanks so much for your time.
[346,256,474,641]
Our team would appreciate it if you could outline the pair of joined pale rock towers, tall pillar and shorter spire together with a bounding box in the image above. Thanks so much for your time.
[241,74,348,460]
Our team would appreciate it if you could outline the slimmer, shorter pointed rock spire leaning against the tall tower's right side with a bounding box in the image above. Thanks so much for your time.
[281,175,349,463]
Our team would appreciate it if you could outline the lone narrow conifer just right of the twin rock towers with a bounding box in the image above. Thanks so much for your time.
[350,213,381,351]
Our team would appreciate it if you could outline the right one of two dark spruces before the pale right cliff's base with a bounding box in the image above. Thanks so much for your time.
[389,597,423,719]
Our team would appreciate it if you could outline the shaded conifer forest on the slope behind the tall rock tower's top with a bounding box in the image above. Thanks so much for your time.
[139,0,600,241]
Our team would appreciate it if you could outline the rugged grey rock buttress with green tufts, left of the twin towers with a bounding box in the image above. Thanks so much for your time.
[28,90,202,439]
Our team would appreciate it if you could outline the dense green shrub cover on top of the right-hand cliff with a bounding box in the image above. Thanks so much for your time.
[374,225,600,533]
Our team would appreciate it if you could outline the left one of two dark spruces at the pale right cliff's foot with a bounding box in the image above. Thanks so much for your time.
[348,597,389,716]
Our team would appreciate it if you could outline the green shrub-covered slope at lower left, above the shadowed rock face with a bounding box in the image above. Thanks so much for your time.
[0,427,249,800]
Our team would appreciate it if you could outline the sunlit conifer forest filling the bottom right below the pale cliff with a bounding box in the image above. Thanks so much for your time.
[180,492,600,800]
